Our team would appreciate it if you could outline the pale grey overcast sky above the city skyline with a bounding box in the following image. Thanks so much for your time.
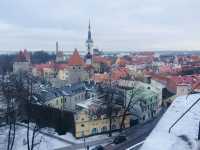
[0,0,200,51]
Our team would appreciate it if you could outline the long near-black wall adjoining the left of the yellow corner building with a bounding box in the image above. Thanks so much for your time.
[25,104,75,134]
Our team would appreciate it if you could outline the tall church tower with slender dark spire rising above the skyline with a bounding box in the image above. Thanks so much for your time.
[85,21,93,65]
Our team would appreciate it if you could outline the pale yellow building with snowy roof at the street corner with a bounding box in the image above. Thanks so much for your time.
[74,100,130,138]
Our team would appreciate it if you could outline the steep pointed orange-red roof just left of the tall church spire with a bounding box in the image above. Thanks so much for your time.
[68,49,84,66]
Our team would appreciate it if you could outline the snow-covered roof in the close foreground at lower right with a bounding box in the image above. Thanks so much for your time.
[140,94,200,150]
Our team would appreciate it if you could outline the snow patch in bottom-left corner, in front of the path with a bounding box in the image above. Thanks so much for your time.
[0,126,69,150]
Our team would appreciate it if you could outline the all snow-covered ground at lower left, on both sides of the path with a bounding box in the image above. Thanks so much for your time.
[0,124,115,150]
